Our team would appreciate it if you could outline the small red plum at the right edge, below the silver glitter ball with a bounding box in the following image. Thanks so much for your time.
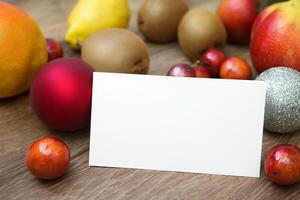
[264,144,300,185]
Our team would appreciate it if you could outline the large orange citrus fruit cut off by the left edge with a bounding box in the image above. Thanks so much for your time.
[0,2,47,99]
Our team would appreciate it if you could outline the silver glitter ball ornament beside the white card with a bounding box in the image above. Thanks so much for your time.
[256,67,300,133]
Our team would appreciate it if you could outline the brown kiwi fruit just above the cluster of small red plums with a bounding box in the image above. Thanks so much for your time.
[178,8,227,59]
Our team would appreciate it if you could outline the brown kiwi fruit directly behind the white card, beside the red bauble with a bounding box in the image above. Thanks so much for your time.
[81,28,149,74]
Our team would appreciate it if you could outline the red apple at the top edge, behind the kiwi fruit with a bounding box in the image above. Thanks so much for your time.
[217,0,258,44]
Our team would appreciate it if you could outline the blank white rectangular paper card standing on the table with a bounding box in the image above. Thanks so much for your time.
[89,72,266,177]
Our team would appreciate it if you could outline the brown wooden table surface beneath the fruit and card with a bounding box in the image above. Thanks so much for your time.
[0,0,300,200]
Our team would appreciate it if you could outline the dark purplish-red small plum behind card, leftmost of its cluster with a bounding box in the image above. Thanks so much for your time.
[167,64,196,77]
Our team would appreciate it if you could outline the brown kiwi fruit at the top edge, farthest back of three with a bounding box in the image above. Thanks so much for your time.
[138,0,189,43]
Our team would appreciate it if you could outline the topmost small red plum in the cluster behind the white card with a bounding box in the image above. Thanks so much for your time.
[199,49,226,77]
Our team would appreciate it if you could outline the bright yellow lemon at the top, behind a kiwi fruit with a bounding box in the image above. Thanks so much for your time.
[65,0,130,49]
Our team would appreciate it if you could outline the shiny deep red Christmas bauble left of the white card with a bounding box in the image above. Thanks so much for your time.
[30,58,93,131]
